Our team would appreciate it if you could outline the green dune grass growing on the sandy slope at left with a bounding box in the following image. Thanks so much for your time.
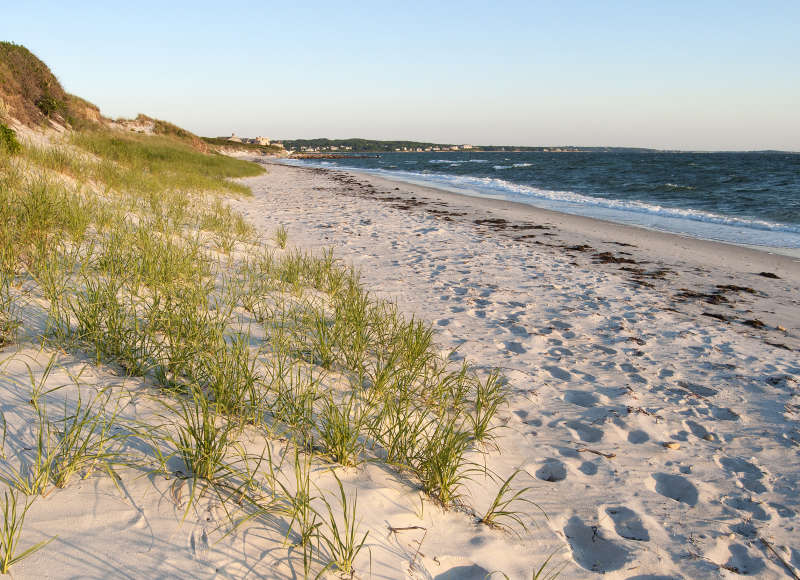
[0,125,525,575]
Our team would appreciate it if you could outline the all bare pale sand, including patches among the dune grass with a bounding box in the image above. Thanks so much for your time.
[7,157,800,579]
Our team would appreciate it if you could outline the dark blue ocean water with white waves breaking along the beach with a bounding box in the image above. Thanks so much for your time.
[280,152,800,248]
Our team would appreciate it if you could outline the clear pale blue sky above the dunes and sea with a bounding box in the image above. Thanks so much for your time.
[0,0,800,150]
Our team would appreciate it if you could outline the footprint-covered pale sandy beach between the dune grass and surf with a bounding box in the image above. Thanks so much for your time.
[225,156,800,578]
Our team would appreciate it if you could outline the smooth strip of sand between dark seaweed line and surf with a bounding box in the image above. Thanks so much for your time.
[258,161,800,340]
